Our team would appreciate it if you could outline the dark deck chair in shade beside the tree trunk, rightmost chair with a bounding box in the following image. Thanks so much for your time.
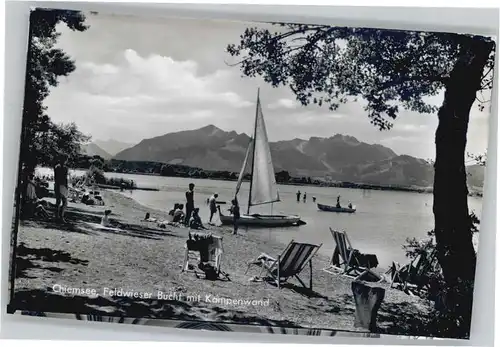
[386,250,437,291]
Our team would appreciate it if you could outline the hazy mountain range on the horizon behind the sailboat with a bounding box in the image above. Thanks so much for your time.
[110,125,454,187]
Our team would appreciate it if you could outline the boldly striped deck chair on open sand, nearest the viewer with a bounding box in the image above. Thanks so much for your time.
[245,240,322,290]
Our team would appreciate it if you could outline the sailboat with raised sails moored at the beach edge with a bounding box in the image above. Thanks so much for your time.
[219,91,305,227]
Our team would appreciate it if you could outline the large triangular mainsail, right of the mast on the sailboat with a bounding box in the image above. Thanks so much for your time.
[249,97,280,206]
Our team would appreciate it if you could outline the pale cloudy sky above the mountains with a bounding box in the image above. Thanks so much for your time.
[45,14,489,159]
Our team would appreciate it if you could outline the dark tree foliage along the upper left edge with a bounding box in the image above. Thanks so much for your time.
[21,9,87,170]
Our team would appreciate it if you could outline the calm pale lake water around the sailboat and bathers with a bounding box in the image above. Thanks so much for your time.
[38,169,482,267]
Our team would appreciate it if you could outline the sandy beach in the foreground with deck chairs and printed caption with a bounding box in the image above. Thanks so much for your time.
[13,191,433,336]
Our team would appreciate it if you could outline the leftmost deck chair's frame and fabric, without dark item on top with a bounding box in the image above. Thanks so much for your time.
[182,232,227,277]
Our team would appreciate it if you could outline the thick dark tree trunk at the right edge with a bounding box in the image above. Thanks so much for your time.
[433,38,493,337]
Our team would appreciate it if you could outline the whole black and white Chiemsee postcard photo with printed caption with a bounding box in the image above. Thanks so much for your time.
[8,9,496,339]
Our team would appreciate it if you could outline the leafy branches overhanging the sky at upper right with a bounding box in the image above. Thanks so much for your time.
[227,23,494,130]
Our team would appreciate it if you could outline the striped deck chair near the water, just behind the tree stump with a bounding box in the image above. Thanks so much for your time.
[323,228,382,281]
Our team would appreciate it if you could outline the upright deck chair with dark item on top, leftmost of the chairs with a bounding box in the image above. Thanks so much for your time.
[182,232,227,277]
